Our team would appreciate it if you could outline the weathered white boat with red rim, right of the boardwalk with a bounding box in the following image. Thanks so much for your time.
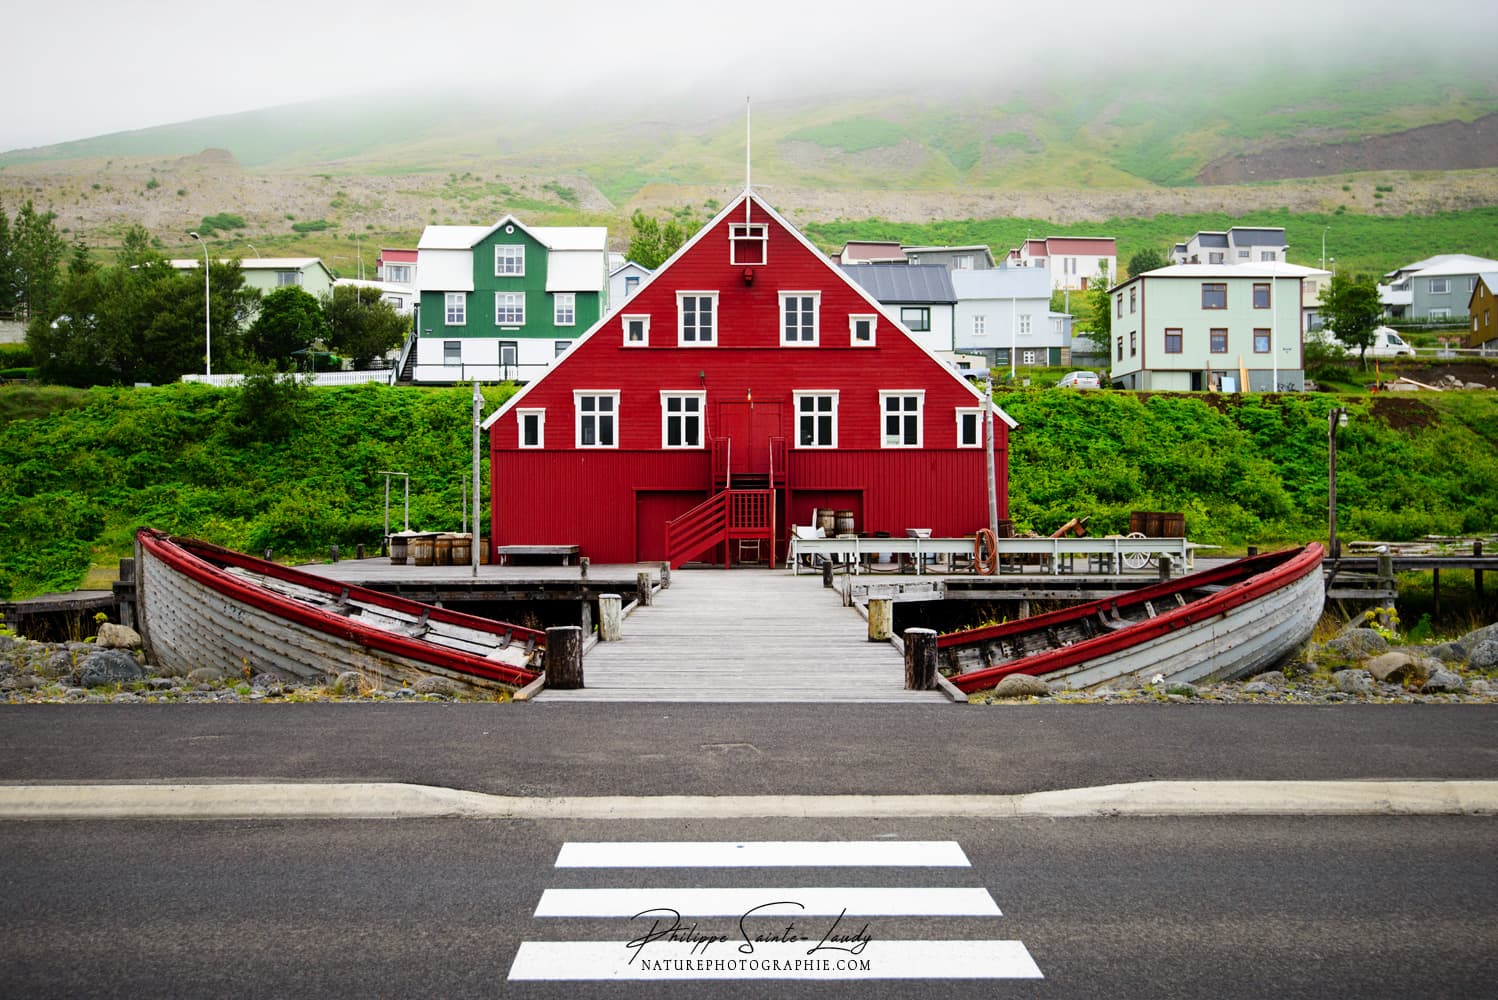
[936,543,1324,693]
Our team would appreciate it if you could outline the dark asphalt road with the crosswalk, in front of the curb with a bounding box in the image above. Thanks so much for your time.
[0,817,1498,1000]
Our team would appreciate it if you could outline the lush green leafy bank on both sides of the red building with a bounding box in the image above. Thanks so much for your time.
[0,385,1498,597]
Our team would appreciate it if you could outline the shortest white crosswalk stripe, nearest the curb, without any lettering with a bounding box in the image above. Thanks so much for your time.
[556,840,972,868]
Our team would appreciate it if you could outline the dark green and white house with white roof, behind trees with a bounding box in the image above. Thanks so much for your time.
[406,216,608,383]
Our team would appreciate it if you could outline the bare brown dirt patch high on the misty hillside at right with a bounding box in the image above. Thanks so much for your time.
[1197,114,1498,184]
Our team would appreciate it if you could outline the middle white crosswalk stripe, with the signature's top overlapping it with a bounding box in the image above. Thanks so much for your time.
[535,886,1001,918]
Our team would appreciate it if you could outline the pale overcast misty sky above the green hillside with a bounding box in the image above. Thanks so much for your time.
[0,0,1498,151]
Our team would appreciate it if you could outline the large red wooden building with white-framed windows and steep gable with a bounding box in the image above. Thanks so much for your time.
[485,192,1014,566]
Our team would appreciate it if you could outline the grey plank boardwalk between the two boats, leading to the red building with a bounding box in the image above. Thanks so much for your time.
[539,569,950,704]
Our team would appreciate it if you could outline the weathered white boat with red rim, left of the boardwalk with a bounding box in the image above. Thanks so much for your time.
[135,528,545,692]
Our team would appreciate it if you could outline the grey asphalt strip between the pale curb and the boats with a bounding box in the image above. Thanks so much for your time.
[0,702,1498,795]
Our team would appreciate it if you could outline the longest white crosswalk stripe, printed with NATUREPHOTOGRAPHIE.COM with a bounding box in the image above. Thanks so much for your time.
[509,940,1044,981]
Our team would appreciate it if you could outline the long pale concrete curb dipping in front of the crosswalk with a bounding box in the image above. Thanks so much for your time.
[0,780,1498,822]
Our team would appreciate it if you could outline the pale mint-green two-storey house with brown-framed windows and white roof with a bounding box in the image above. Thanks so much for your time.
[1109,260,1321,392]
